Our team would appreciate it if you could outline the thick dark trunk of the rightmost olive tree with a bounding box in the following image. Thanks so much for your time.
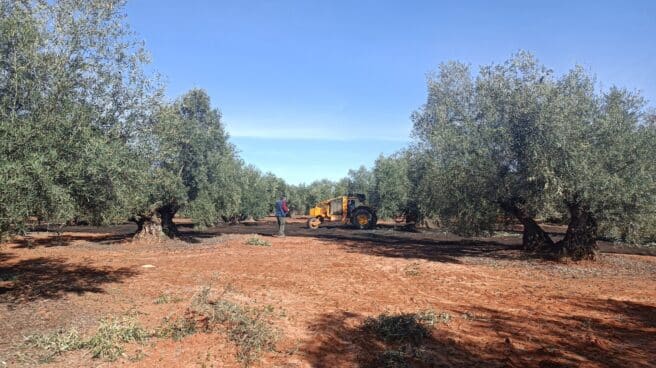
[557,203,597,261]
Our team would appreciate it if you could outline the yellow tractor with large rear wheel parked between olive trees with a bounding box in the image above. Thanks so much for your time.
[307,194,378,229]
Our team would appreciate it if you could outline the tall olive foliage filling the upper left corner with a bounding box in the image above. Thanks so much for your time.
[0,0,160,239]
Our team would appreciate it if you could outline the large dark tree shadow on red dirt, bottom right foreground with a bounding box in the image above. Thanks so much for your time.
[301,299,656,368]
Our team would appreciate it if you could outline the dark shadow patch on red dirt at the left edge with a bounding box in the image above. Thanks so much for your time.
[0,257,138,305]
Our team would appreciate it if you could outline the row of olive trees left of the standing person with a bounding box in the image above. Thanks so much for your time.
[0,0,284,240]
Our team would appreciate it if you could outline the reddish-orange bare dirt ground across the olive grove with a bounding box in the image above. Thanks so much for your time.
[0,219,656,368]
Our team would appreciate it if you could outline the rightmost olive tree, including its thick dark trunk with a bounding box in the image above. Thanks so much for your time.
[550,84,656,258]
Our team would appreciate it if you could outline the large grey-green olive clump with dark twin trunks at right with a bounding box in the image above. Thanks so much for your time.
[413,52,656,259]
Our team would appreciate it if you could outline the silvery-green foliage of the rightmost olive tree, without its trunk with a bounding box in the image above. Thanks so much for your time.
[554,88,656,249]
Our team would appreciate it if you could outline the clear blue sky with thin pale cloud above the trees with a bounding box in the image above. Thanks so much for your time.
[127,0,656,184]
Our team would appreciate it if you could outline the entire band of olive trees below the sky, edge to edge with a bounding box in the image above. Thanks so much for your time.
[0,0,656,259]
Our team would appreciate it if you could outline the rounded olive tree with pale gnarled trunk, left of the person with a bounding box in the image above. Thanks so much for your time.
[135,89,242,236]
